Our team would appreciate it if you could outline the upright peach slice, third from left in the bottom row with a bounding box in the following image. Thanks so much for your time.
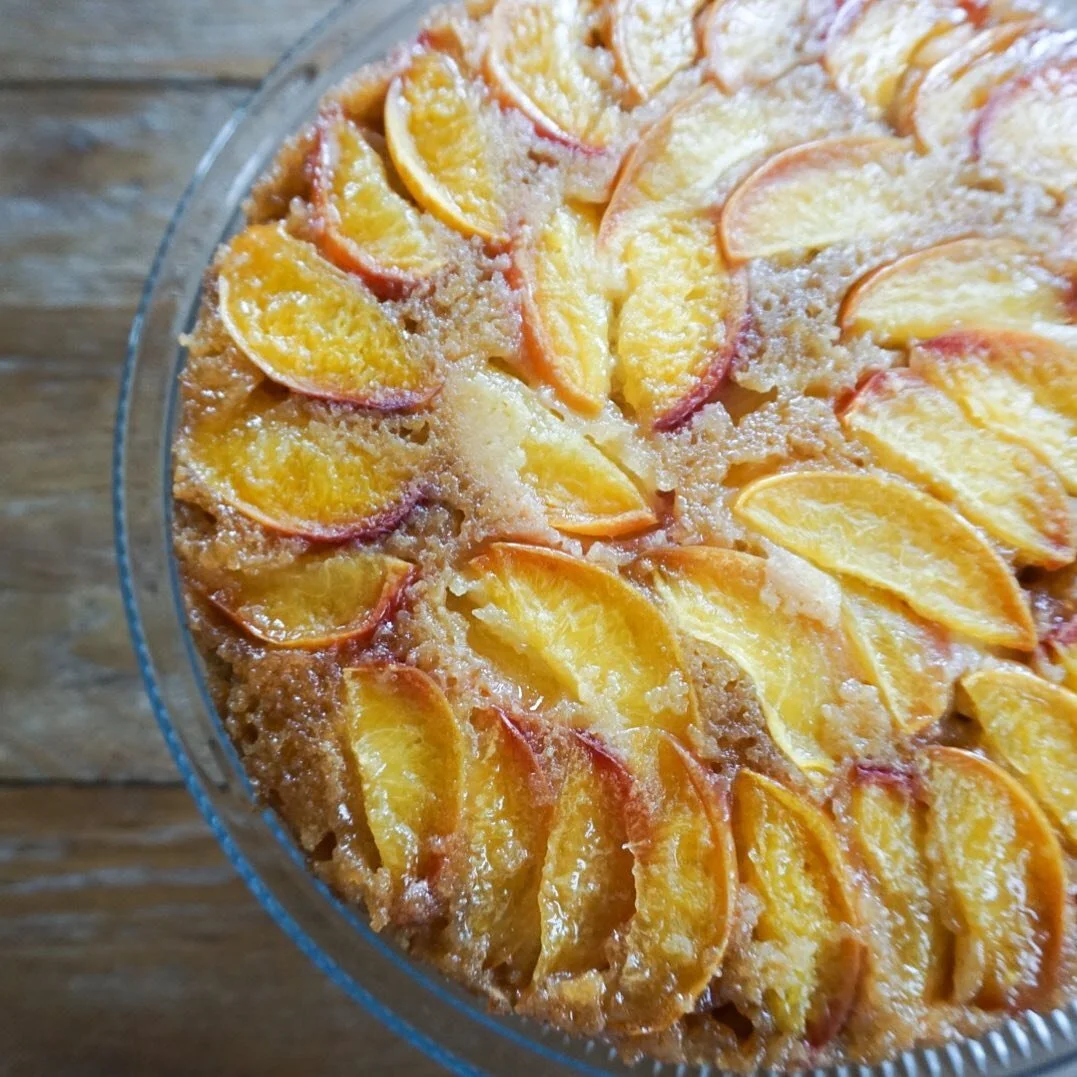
[534,735,635,988]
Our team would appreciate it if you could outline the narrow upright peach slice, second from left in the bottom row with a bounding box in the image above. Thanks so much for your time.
[464,710,554,982]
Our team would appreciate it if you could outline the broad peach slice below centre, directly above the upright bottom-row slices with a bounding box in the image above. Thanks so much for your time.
[471,543,697,738]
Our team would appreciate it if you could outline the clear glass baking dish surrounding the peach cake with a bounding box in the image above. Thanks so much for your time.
[113,0,1077,1077]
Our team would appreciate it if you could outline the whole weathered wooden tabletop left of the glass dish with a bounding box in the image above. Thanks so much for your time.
[0,0,440,1077]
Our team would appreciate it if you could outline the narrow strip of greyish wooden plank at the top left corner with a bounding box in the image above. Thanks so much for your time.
[0,0,336,81]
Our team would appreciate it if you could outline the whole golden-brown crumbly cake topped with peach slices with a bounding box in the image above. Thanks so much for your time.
[173,0,1077,1072]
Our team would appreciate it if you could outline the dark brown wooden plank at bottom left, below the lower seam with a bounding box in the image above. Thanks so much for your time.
[0,787,442,1077]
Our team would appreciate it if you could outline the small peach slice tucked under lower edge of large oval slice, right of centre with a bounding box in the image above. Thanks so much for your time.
[841,577,953,733]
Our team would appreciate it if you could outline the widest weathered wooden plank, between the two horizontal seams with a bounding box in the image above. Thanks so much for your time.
[0,84,243,781]
